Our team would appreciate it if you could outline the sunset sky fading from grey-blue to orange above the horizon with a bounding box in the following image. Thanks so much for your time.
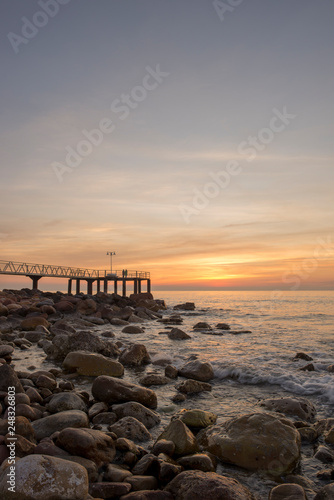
[0,0,334,290]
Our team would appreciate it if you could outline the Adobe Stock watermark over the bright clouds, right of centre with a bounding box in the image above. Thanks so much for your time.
[178,106,296,224]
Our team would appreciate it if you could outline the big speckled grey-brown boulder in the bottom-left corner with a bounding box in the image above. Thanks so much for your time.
[0,455,88,500]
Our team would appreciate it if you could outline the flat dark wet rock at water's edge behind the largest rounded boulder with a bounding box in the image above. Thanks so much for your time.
[260,398,316,422]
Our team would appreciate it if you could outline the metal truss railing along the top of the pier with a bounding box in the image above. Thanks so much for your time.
[0,260,150,280]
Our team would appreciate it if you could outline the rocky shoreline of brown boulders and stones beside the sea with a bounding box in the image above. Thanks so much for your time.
[0,289,334,500]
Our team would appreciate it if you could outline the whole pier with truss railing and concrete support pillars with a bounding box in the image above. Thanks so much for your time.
[0,260,151,297]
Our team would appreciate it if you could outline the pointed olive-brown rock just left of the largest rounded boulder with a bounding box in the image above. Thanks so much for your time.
[157,420,199,456]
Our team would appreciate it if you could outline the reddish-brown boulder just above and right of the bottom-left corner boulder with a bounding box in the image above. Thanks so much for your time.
[56,427,116,467]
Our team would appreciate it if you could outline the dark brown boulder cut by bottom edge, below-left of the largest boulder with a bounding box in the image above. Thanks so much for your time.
[165,471,254,500]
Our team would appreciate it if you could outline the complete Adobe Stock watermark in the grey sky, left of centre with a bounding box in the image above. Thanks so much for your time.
[51,64,170,183]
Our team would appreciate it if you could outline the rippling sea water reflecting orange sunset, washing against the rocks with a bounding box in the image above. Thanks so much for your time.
[14,291,334,499]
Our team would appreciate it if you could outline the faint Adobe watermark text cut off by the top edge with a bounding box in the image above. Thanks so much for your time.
[7,0,70,54]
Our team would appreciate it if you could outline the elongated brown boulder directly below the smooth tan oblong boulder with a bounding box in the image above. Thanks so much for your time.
[92,375,158,409]
